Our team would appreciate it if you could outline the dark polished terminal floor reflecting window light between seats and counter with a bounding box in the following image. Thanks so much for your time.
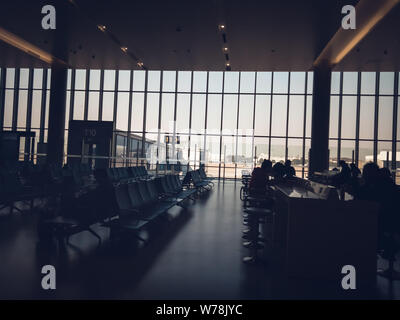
[0,181,400,299]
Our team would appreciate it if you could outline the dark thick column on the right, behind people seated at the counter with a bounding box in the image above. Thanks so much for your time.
[309,66,332,173]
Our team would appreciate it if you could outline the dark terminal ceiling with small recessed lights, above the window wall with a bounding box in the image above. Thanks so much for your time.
[0,0,400,71]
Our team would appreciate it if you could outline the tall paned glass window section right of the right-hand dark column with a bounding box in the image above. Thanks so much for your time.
[330,72,398,178]
